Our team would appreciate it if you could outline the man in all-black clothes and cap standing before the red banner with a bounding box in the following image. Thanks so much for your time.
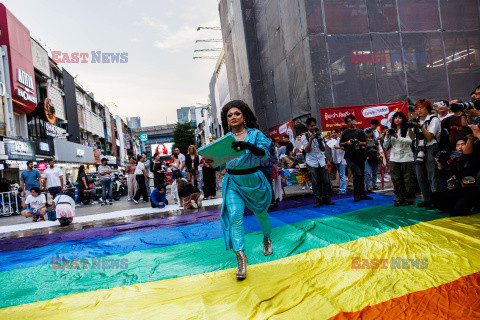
[340,114,373,202]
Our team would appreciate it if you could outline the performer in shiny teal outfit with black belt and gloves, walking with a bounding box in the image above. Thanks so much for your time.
[220,100,273,280]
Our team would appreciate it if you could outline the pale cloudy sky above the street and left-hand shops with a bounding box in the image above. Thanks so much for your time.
[0,0,222,126]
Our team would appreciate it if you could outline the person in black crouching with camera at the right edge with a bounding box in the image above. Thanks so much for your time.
[432,125,480,216]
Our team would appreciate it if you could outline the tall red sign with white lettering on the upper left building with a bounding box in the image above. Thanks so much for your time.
[0,3,37,113]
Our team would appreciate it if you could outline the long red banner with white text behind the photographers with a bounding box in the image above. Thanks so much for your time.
[320,101,408,131]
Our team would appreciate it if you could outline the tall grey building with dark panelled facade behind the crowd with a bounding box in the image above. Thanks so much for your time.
[219,0,480,129]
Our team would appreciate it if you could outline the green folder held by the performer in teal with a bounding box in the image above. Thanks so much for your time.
[198,135,245,167]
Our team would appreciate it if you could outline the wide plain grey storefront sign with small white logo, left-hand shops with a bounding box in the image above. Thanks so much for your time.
[53,138,95,164]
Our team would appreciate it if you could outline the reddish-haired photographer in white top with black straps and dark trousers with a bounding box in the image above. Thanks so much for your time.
[409,99,441,209]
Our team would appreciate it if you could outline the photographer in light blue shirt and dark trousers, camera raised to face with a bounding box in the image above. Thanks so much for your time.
[302,118,334,208]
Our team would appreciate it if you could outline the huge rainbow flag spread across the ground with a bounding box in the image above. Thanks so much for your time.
[0,195,480,320]
